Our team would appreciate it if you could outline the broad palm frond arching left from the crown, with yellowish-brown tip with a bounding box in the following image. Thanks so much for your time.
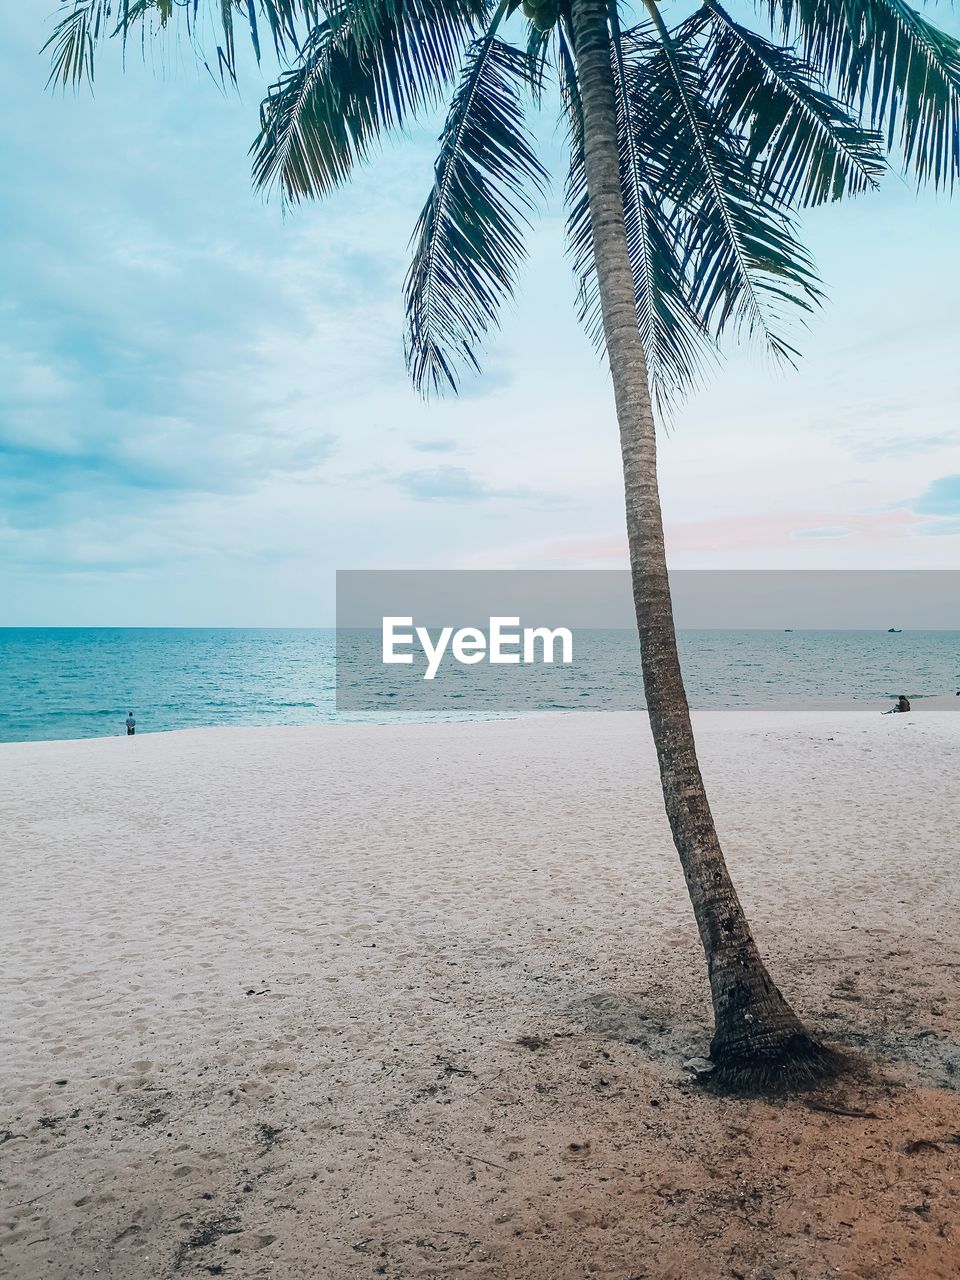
[251,0,489,202]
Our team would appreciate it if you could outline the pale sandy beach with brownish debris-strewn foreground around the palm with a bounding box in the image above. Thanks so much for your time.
[0,708,960,1280]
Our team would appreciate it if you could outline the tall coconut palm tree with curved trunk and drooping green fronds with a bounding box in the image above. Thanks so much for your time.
[49,0,960,1087]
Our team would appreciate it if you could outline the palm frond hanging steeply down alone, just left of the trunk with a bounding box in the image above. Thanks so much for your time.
[404,33,547,393]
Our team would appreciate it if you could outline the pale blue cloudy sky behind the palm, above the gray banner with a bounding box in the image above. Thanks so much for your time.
[0,0,960,626]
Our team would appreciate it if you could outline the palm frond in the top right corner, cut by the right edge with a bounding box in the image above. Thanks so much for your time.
[764,0,960,186]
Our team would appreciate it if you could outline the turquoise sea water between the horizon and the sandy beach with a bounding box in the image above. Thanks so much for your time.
[0,628,960,742]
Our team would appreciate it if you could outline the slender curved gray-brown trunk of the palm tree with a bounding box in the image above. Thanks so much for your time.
[572,0,831,1088]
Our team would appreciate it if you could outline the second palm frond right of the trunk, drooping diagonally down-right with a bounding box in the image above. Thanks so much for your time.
[623,20,822,361]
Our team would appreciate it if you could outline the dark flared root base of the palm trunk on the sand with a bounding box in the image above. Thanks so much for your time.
[709,1030,842,1093]
